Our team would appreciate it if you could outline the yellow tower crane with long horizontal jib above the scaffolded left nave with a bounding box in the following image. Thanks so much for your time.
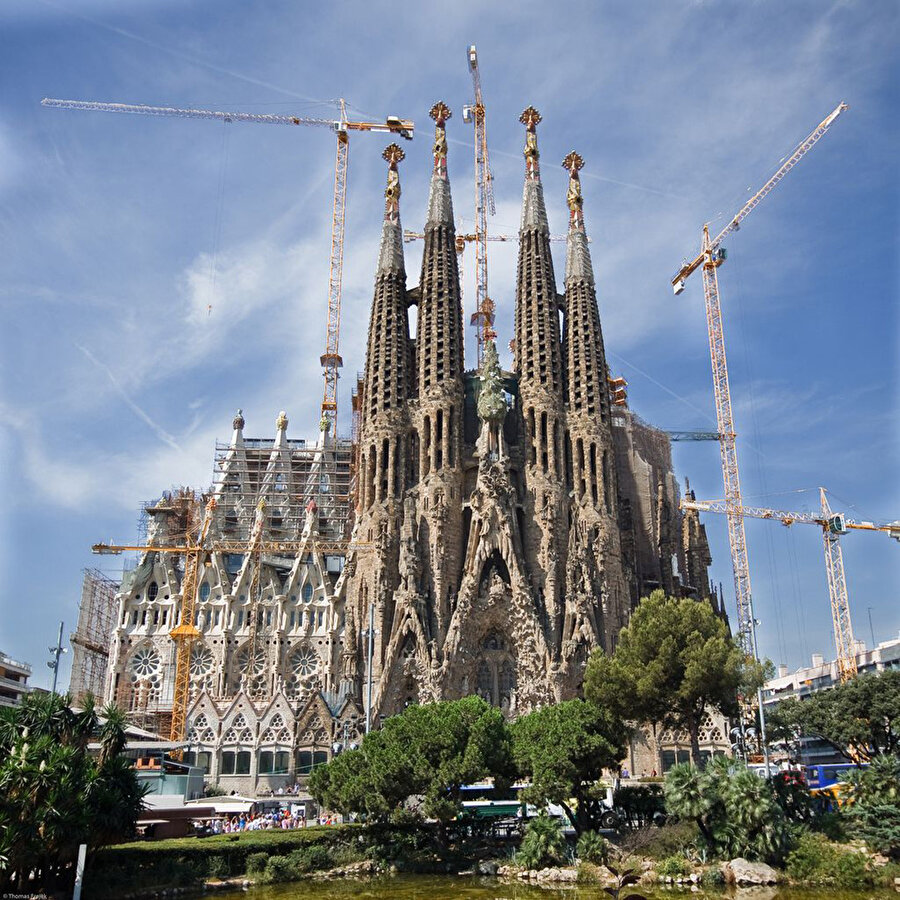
[41,98,415,437]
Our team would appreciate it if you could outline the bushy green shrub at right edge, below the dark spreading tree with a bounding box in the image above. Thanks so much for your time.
[843,756,900,860]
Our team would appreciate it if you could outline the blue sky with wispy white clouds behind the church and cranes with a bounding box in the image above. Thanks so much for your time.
[0,0,900,685]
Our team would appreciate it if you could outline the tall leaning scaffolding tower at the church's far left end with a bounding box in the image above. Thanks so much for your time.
[69,569,119,703]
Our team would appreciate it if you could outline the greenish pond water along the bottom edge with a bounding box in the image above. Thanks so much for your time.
[207,875,898,900]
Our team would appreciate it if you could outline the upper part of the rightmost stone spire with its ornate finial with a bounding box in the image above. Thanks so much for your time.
[563,150,609,423]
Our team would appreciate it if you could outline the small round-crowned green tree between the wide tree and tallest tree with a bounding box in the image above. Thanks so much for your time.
[512,700,628,835]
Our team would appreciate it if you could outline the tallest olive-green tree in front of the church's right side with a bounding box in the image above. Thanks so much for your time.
[584,591,763,765]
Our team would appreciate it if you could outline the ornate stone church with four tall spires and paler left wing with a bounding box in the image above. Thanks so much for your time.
[108,104,724,790]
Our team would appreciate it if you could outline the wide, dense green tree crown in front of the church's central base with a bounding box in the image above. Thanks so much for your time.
[309,697,513,823]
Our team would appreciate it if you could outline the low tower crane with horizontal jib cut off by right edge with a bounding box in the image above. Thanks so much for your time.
[681,488,900,681]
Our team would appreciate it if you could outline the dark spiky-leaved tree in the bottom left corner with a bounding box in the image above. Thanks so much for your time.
[0,694,145,891]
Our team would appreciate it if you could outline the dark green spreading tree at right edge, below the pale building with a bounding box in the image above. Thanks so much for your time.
[770,669,900,761]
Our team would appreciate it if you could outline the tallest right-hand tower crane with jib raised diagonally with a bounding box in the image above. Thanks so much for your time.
[672,103,848,657]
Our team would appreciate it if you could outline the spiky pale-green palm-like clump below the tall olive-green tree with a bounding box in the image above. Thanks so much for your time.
[665,757,790,864]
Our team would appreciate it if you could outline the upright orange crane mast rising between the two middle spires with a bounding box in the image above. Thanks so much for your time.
[463,44,497,368]
